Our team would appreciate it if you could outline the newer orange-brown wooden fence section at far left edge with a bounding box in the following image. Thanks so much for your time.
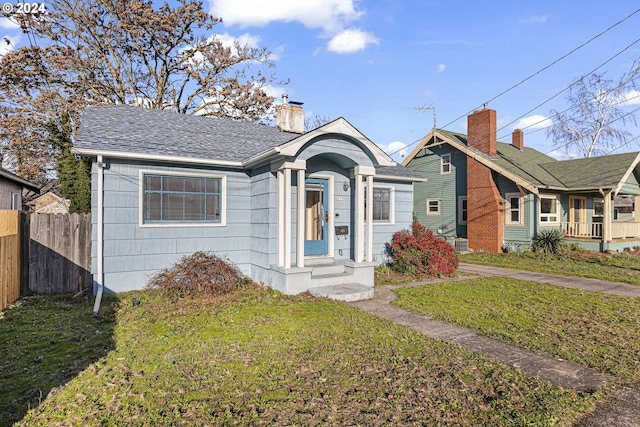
[0,210,21,311]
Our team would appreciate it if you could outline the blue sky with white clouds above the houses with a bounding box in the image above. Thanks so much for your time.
[5,0,640,160]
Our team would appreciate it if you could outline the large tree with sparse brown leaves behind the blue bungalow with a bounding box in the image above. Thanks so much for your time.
[0,0,283,182]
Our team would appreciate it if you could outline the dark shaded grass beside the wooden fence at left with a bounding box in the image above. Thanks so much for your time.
[0,295,118,426]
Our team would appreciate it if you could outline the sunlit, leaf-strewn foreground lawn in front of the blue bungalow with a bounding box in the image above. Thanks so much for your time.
[7,288,595,426]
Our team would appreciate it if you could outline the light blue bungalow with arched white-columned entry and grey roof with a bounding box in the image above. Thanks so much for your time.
[74,103,422,300]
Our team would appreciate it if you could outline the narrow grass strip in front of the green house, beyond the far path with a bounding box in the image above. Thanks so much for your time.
[460,252,640,285]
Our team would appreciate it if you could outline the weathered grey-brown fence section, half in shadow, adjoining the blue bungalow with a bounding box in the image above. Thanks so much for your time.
[29,214,92,293]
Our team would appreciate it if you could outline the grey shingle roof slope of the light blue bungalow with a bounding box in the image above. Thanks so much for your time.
[74,105,298,162]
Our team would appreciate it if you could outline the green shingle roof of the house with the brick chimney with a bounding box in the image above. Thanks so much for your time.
[438,129,638,189]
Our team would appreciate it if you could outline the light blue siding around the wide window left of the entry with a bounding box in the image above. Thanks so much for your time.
[92,159,252,292]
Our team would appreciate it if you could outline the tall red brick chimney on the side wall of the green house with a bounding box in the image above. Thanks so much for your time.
[467,108,504,253]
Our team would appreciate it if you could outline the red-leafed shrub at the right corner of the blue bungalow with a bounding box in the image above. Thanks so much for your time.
[389,220,458,276]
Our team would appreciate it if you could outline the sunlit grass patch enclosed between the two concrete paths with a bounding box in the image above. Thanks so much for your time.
[394,277,640,379]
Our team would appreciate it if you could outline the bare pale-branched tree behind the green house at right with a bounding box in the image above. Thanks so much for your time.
[547,60,640,157]
